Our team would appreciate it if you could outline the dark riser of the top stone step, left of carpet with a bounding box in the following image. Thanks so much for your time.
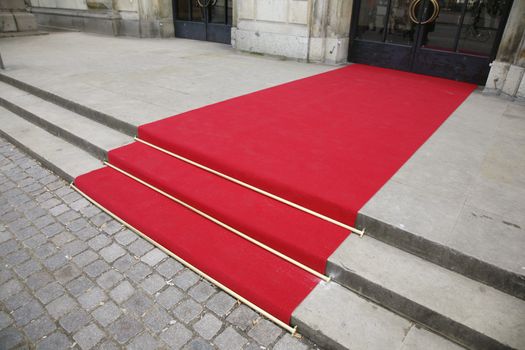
[0,73,137,136]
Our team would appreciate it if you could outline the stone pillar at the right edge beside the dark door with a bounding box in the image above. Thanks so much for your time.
[484,0,525,99]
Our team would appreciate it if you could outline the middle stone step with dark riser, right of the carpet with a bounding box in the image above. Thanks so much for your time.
[327,235,525,349]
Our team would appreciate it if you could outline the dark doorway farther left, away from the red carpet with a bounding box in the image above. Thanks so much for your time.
[173,0,232,44]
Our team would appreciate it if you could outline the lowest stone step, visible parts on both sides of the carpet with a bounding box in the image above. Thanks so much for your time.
[0,115,461,350]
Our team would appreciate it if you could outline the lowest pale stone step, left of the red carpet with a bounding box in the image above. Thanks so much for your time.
[0,107,102,182]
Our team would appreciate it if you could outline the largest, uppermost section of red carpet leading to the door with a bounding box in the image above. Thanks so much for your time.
[139,64,476,225]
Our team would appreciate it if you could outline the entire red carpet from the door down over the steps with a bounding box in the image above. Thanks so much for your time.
[75,65,475,322]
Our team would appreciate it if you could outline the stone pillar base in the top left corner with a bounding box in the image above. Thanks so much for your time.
[0,0,38,33]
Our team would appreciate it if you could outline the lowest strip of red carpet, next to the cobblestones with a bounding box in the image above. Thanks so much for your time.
[75,168,319,323]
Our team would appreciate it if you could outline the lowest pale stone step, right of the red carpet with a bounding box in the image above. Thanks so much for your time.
[292,282,462,350]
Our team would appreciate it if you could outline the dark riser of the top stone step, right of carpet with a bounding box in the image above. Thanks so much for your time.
[356,213,525,300]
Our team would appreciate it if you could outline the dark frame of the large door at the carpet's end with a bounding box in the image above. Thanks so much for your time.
[348,0,514,85]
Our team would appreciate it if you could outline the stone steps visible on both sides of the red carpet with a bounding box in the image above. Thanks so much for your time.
[0,75,525,349]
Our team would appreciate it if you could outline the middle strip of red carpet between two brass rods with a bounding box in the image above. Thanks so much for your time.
[108,142,349,273]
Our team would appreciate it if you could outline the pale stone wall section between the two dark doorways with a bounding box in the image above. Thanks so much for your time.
[232,0,353,63]
